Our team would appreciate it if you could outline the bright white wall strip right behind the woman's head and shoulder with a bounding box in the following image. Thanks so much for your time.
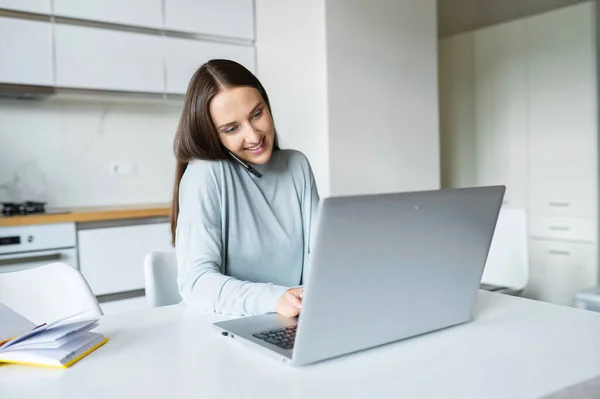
[256,0,329,197]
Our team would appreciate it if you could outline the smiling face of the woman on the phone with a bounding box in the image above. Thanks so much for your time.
[210,86,275,164]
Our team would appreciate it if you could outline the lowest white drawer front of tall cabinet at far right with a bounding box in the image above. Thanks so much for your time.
[524,240,598,306]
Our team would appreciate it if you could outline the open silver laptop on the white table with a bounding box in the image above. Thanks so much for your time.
[214,186,505,366]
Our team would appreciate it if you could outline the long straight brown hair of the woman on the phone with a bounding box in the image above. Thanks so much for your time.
[171,59,279,246]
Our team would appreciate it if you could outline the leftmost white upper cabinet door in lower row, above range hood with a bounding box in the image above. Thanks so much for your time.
[0,17,54,86]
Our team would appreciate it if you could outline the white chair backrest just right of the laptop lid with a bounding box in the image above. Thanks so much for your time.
[481,208,529,290]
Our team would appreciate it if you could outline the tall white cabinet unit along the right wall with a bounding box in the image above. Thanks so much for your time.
[440,2,598,305]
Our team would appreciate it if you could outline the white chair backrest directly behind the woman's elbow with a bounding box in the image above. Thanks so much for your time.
[144,251,182,307]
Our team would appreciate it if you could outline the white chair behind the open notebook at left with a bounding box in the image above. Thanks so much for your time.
[0,262,102,323]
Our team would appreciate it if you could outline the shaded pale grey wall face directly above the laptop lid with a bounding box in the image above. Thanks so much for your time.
[326,0,440,195]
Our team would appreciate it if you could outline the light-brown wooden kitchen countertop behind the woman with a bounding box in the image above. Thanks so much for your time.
[0,204,171,227]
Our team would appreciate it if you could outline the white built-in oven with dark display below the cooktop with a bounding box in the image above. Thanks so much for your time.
[0,223,79,273]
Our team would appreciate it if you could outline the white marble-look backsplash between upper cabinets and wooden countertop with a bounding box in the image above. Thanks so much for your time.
[0,99,179,207]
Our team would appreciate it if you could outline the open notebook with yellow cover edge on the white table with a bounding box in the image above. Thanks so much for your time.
[0,303,108,368]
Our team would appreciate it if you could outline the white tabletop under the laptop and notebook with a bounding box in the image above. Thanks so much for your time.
[0,291,600,399]
